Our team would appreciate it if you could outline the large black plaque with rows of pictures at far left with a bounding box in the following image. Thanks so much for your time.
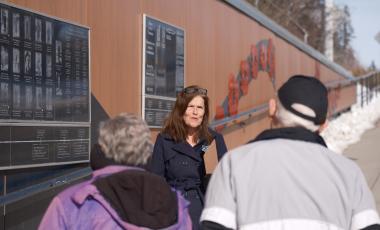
[0,3,90,169]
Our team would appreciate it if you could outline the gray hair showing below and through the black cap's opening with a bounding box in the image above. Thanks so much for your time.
[276,100,319,132]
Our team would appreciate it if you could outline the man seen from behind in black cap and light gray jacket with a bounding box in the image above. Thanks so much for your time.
[201,75,380,230]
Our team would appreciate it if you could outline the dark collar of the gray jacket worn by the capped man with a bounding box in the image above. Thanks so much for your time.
[248,127,327,148]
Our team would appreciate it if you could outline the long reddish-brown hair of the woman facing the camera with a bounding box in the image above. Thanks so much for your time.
[161,85,213,144]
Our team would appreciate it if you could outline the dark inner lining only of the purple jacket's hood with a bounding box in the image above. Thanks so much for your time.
[93,170,178,229]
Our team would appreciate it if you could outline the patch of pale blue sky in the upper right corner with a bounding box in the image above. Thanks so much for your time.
[334,0,380,69]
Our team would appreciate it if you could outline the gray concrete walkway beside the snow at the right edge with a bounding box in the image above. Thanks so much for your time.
[343,121,380,213]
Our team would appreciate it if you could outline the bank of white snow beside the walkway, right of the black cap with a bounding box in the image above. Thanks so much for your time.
[321,90,380,153]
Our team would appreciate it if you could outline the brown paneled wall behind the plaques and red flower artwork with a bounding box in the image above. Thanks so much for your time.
[5,0,355,172]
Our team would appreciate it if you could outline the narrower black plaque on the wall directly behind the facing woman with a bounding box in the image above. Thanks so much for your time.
[142,15,184,127]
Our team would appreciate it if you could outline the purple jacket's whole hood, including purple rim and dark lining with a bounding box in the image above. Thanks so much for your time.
[70,165,191,230]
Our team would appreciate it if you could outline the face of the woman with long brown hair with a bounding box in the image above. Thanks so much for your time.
[183,96,205,129]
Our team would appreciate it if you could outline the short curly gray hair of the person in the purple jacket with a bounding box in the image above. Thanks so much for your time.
[98,113,153,165]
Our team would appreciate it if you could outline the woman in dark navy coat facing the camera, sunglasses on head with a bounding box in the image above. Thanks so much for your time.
[150,85,227,229]
